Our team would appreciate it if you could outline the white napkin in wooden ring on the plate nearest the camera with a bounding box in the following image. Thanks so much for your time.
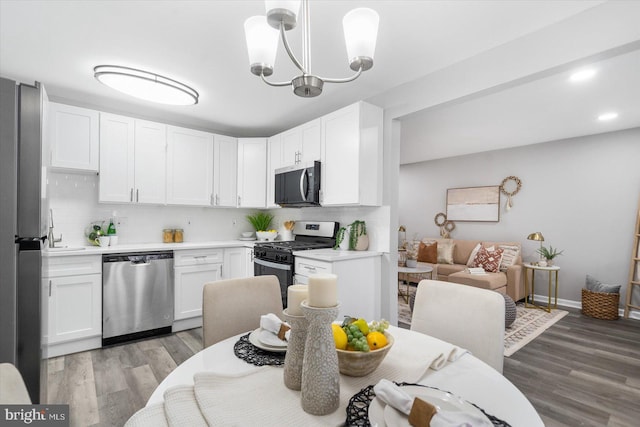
[373,379,492,427]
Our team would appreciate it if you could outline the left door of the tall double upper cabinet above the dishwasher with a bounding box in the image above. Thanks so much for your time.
[98,113,135,202]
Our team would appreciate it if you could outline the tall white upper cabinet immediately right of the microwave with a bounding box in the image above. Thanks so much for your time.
[320,102,383,206]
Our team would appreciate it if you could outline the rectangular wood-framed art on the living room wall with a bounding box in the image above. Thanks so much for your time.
[447,185,500,222]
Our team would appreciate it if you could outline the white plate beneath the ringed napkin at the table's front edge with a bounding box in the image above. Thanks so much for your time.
[369,386,491,427]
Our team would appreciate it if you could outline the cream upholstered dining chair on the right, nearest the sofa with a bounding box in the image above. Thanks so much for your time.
[411,280,505,373]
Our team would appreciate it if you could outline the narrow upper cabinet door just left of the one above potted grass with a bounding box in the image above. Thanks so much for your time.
[213,135,238,208]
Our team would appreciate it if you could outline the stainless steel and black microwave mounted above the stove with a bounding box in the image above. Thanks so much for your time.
[275,161,320,208]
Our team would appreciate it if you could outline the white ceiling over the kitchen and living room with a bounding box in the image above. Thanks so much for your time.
[0,0,640,163]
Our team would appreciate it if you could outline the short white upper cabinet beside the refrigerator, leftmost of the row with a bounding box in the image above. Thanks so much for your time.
[47,102,99,172]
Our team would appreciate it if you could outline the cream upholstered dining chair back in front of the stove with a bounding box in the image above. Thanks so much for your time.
[202,276,282,348]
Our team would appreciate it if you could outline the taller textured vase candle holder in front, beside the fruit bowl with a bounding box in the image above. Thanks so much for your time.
[300,302,340,415]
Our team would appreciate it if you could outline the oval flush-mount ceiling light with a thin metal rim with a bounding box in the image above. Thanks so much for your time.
[93,65,200,105]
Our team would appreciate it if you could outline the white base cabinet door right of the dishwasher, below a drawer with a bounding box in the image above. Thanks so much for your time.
[174,264,222,320]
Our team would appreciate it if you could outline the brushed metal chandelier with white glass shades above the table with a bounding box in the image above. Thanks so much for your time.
[244,0,380,98]
